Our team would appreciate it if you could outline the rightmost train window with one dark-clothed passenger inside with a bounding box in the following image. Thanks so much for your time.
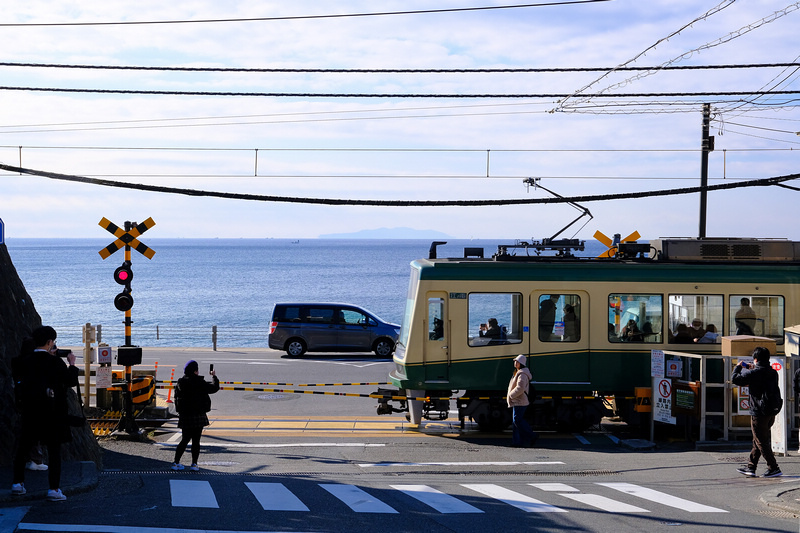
[728,294,785,344]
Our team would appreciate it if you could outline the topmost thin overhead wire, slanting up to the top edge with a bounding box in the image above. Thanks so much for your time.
[0,0,611,28]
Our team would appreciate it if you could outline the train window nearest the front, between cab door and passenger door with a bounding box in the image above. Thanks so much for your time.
[467,293,522,346]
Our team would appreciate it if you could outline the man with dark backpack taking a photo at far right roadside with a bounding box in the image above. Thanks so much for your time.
[731,346,783,477]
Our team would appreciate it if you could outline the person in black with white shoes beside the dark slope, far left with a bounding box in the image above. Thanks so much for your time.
[11,326,78,501]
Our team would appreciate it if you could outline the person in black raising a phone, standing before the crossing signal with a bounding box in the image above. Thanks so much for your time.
[171,361,219,471]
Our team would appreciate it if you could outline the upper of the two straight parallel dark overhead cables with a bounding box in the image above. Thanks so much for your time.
[0,61,800,74]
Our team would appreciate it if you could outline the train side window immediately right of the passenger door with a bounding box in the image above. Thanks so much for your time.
[608,294,664,343]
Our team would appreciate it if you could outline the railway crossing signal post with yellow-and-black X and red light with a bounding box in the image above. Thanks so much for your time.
[98,217,156,435]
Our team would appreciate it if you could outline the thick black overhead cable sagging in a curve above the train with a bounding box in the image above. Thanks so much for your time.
[0,164,800,207]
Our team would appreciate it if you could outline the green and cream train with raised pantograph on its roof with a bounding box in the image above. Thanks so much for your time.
[378,239,800,430]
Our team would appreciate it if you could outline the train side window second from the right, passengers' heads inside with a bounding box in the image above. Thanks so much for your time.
[667,294,724,344]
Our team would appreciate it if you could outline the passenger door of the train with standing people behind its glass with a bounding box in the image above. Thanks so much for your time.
[529,291,589,385]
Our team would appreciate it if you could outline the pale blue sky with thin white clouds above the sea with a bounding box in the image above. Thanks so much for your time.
[0,0,800,242]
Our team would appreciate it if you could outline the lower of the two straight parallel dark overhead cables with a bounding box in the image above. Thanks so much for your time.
[0,86,800,99]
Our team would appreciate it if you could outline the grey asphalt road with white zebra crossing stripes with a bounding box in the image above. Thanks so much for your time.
[7,350,800,533]
